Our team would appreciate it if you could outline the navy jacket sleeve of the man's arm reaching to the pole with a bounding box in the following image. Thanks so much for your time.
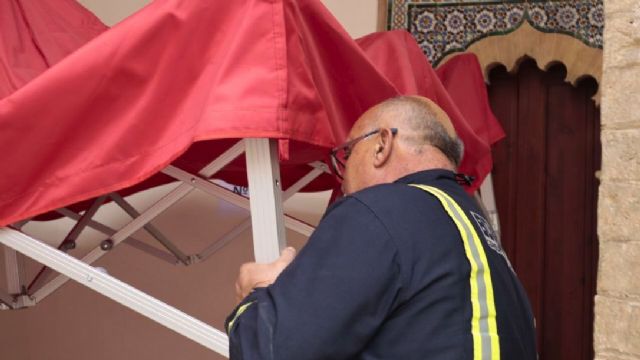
[227,197,401,360]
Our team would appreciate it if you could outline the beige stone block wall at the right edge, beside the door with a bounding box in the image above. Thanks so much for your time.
[594,0,640,360]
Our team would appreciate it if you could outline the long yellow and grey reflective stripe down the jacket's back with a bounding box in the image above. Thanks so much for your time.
[412,184,500,360]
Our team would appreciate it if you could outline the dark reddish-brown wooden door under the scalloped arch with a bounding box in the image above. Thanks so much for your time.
[489,60,601,360]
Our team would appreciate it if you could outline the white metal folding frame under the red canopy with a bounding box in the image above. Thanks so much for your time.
[0,139,328,356]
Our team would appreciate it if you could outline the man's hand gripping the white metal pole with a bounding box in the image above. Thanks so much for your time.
[236,247,296,302]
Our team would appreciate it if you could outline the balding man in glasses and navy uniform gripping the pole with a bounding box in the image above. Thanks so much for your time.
[227,97,536,360]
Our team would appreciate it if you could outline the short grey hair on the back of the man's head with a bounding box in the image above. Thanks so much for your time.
[379,96,464,167]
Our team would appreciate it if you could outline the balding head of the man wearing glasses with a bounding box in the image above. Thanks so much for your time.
[343,96,462,194]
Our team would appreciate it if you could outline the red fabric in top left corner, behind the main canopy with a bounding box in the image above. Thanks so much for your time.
[0,0,107,99]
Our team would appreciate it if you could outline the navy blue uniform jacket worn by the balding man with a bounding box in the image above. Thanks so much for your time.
[227,170,536,360]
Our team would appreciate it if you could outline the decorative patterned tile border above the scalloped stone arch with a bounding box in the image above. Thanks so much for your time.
[387,0,604,66]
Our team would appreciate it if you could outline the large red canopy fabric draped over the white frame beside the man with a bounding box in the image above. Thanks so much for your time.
[0,0,502,225]
